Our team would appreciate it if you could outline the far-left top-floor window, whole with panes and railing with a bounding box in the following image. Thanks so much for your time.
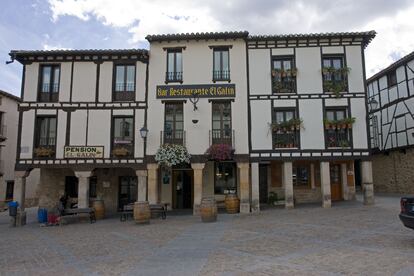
[39,65,60,102]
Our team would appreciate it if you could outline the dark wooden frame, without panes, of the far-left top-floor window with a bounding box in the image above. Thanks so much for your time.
[37,64,62,102]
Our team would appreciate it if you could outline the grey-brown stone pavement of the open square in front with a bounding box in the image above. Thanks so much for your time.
[0,196,414,275]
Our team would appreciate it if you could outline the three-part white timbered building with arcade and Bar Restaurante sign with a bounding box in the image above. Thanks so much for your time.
[10,31,375,224]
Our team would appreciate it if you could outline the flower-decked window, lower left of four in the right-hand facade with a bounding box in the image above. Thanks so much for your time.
[272,108,300,148]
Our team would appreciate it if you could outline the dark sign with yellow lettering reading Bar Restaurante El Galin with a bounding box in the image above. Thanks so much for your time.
[157,84,236,99]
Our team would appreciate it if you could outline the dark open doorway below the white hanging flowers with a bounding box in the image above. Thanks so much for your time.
[172,170,193,209]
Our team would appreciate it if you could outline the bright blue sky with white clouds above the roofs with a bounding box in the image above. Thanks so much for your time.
[0,0,414,96]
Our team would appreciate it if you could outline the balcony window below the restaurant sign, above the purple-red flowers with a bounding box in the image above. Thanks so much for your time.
[211,101,232,145]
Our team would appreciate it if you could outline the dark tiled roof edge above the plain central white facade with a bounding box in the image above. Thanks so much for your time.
[145,31,249,42]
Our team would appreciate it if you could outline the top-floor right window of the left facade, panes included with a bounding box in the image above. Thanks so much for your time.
[114,64,135,101]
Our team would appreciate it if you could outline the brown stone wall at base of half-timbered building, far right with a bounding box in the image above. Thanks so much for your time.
[372,149,414,194]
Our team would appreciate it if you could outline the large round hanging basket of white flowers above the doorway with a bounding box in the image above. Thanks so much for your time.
[155,144,191,167]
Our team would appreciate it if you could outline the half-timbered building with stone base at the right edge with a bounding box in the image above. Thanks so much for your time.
[367,52,414,194]
